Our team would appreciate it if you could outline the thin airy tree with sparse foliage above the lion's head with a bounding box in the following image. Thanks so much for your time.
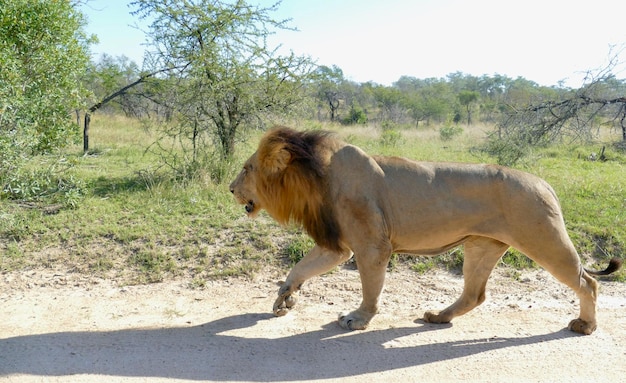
[131,0,313,164]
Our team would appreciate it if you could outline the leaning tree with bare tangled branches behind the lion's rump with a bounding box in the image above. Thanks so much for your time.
[484,51,626,165]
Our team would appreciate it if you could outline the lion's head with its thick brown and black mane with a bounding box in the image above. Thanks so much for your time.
[230,127,343,254]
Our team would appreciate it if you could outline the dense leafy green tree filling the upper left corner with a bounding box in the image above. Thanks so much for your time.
[0,0,93,179]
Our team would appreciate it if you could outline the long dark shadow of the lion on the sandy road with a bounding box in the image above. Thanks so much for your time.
[0,314,575,381]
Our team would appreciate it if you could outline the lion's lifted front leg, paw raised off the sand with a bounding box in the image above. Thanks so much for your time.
[273,246,352,316]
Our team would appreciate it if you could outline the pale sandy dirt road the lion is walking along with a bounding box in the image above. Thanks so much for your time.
[0,269,626,383]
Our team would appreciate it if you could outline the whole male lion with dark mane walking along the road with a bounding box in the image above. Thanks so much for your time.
[230,127,621,334]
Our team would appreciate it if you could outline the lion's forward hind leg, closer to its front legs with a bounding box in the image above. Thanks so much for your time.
[424,237,509,323]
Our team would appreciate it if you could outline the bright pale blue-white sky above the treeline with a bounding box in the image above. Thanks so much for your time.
[83,0,626,88]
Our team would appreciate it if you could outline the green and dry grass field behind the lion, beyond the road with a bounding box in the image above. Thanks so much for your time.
[0,115,626,287]
